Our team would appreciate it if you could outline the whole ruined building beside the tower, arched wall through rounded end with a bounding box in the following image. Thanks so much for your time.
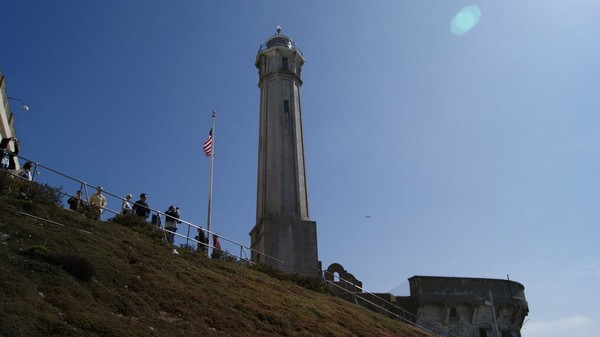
[325,263,529,337]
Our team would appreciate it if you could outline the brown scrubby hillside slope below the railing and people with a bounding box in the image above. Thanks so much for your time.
[0,196,430,337]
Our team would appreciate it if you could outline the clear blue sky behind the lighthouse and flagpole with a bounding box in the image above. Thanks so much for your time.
[0,0,600,337]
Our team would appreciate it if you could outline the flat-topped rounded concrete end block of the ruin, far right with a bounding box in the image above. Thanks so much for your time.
[406,276,529,337]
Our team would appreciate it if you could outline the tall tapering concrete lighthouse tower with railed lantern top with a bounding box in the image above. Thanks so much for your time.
[250,27,320,276]
